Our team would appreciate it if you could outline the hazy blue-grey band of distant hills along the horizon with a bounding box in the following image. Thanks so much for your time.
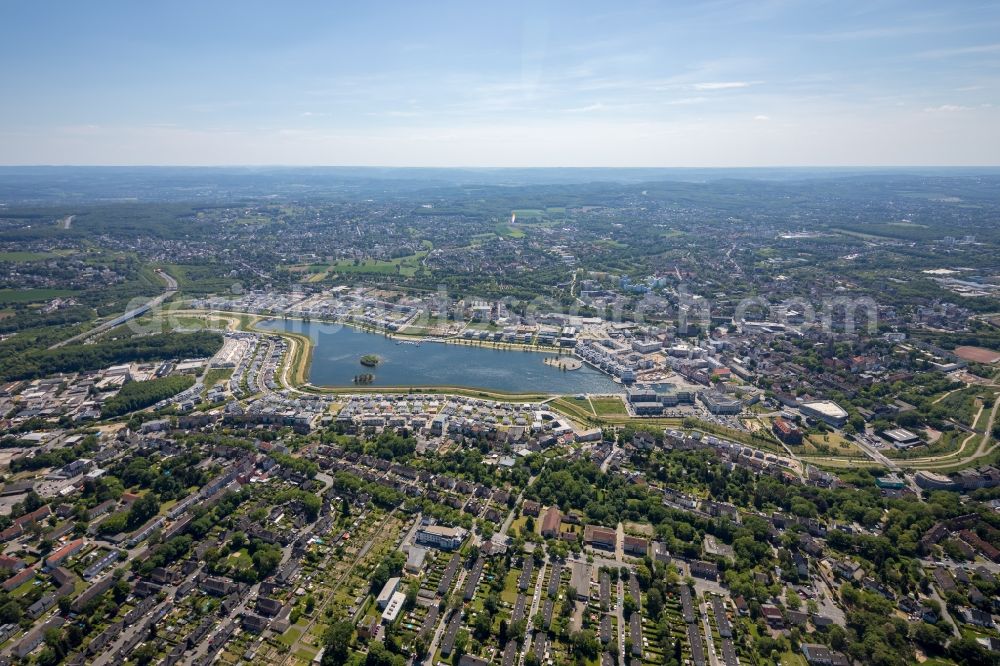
[0,166,1000,204]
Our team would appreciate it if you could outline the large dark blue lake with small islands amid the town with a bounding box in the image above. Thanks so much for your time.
[257,319,624,394]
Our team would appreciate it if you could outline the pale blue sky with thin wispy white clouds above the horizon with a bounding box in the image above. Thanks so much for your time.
[0,0,1000,166]
